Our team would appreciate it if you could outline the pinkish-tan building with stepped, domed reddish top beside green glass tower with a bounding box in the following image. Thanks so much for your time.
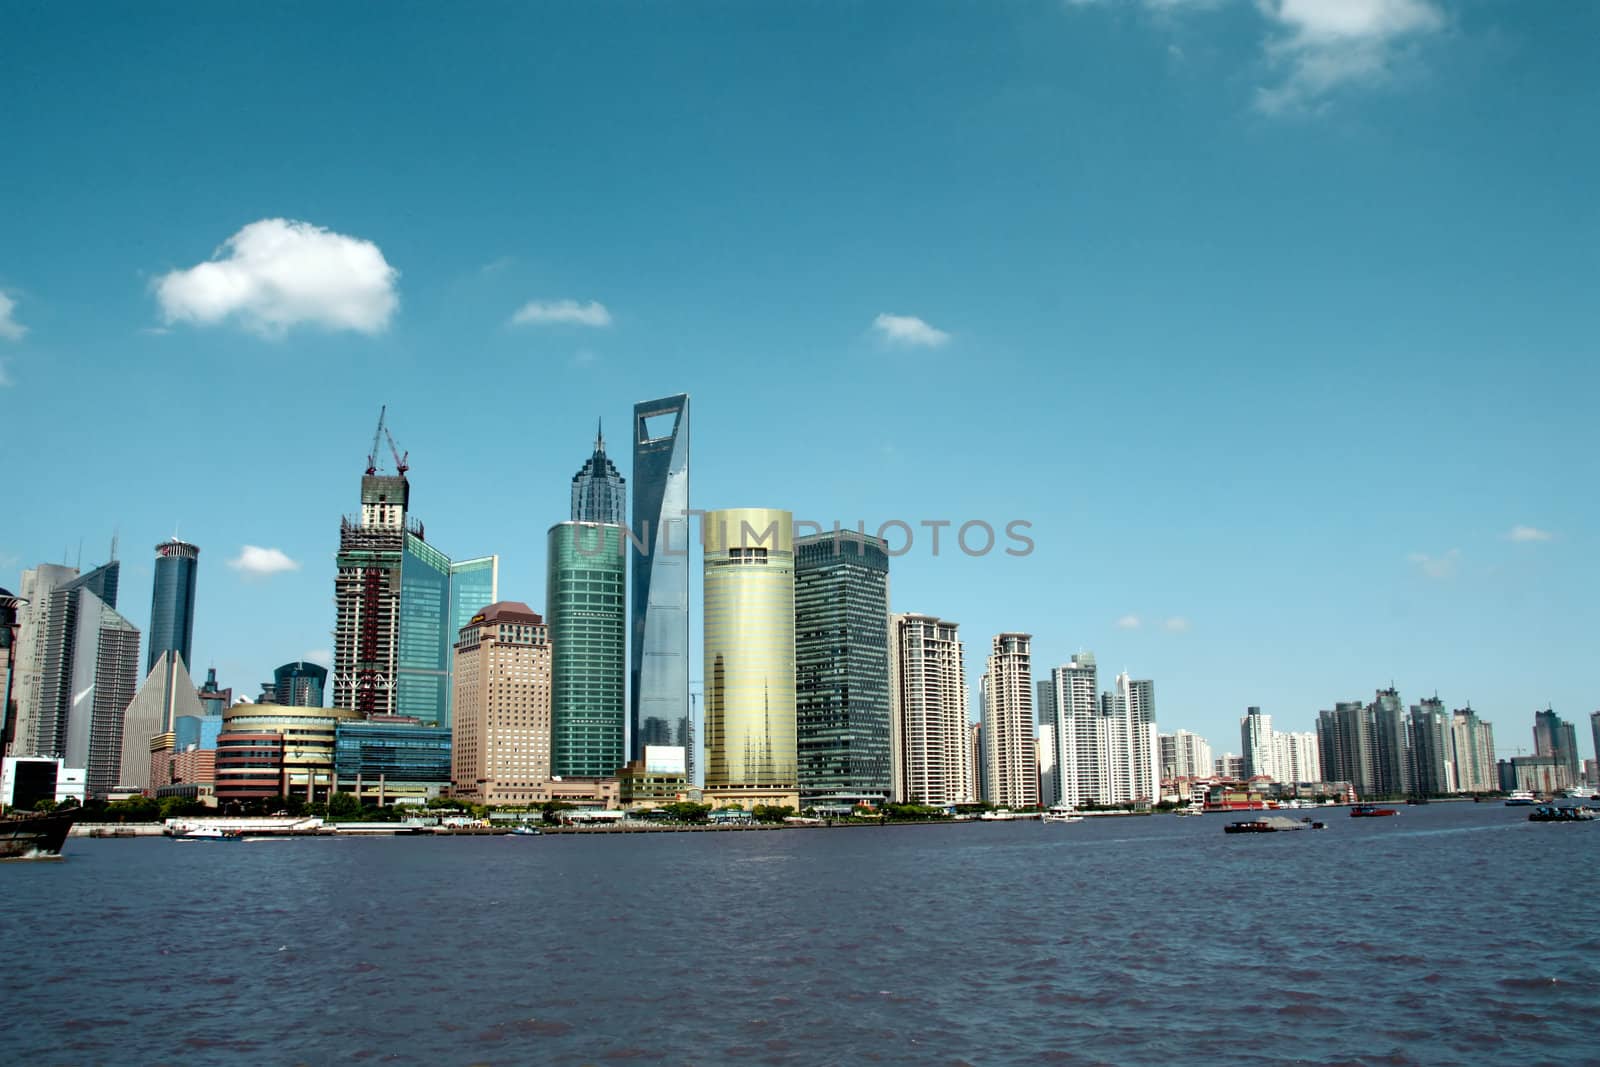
[451,600,550,805]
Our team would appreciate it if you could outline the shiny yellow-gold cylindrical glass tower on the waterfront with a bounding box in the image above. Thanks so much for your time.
[702,507,800,808]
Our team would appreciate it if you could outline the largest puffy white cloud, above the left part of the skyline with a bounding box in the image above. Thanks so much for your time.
[155,219,400,338]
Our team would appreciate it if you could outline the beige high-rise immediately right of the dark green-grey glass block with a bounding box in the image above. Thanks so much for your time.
[890,614,982,805]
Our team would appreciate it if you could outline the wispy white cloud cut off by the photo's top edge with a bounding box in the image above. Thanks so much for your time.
[1256,0,1445,115]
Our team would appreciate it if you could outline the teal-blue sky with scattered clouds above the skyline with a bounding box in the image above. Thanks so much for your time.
[0,0,1600,755]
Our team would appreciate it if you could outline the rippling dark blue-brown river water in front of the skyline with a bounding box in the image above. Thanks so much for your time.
[0,803,1600,1067]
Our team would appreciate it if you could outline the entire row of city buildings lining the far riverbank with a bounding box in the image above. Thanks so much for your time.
[0,394,1600,814]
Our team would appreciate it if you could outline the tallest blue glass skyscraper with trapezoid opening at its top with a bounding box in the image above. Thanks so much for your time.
[629,394,688,782]
